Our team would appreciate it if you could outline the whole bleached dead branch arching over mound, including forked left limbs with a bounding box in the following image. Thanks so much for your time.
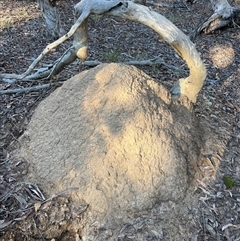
[0,0,206,102]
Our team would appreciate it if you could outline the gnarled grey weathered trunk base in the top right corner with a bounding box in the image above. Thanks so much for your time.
[198,0,240,34]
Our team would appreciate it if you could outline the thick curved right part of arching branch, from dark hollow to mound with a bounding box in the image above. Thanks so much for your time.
[105,1,206,102]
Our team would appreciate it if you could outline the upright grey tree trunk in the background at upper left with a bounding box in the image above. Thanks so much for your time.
[37,0,63,39]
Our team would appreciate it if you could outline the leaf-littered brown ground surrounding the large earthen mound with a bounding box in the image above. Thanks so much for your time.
[0,0,240,241]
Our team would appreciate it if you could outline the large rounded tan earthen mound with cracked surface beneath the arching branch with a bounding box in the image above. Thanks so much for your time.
[16,64,201,240]
